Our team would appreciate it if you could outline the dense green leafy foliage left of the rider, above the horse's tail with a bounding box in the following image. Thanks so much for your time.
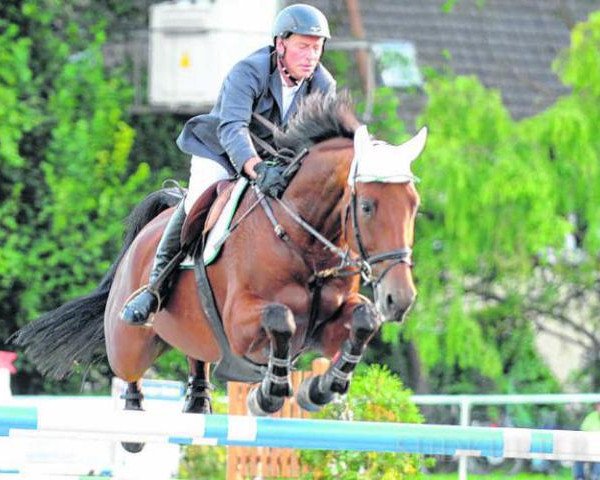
[0,0,155,388]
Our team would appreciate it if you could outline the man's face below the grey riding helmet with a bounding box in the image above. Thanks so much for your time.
[277,35,324,79]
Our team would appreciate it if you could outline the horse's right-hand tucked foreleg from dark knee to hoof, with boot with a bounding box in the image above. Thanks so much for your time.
[296,303,382,412]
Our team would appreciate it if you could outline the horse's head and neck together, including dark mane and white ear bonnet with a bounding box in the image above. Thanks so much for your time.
[276,94,427,320]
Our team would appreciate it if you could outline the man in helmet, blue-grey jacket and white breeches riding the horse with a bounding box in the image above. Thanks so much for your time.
[121,4,336,325]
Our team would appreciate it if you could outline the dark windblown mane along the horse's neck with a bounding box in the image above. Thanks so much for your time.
[274,91,360,151]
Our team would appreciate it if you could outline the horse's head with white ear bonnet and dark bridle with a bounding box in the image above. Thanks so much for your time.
[348,125,427,321]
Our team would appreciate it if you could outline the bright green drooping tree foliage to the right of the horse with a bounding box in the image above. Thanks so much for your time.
[388,13,600,391]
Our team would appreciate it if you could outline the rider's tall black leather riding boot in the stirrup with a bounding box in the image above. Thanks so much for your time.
[121,201,186,325]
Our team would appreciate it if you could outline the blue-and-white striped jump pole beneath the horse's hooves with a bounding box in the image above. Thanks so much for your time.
[0,405,600,462]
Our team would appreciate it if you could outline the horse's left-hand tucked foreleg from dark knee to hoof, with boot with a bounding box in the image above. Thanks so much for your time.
[247,304,296,416]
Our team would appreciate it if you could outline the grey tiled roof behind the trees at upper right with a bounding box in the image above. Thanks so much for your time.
[298,0,600,119]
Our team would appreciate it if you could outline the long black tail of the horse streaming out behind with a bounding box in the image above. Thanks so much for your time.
[9,189,181,379]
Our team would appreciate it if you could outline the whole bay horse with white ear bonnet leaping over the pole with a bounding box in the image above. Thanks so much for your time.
[14,94,426,442]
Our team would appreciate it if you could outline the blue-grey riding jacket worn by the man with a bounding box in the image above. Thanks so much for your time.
[177,47,336,173]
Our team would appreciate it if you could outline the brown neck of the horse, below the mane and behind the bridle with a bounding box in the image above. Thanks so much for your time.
[286,138,353,248]
